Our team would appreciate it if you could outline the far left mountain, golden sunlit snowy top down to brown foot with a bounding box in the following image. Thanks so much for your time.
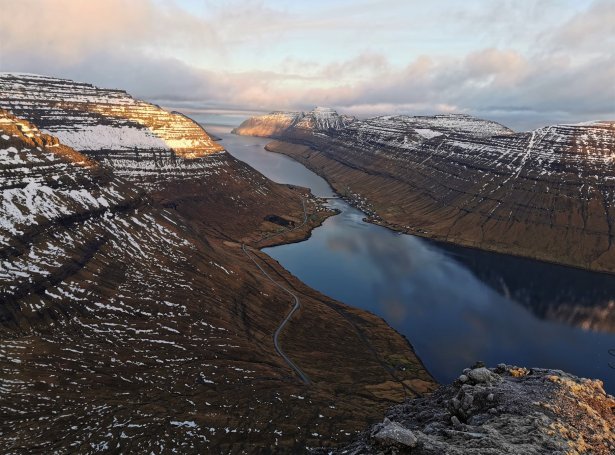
[0,73,318,242]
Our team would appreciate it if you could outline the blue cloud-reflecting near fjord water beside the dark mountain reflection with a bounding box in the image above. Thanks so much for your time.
[267,201,615,394]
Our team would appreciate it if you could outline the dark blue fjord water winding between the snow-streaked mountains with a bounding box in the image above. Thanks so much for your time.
[213,125,615,393]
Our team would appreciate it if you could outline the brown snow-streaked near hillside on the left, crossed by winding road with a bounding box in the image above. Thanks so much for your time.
[0,83,434,453]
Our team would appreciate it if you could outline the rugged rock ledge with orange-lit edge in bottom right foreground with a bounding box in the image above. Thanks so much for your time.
[320,364,615,455]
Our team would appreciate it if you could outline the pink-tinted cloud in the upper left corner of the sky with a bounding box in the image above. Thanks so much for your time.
[0,0,216,64]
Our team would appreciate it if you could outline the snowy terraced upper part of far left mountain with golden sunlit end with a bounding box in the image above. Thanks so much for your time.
[0,73,223,180]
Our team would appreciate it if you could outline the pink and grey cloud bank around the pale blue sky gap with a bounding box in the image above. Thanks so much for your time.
[0,0,615,132]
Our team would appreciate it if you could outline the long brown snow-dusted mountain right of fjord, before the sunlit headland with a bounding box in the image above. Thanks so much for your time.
[239,110,615,272]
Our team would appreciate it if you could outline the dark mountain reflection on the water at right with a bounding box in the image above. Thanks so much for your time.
[430,242,615,333]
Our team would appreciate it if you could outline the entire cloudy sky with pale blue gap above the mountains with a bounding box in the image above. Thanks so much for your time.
[0,0,615,130]
